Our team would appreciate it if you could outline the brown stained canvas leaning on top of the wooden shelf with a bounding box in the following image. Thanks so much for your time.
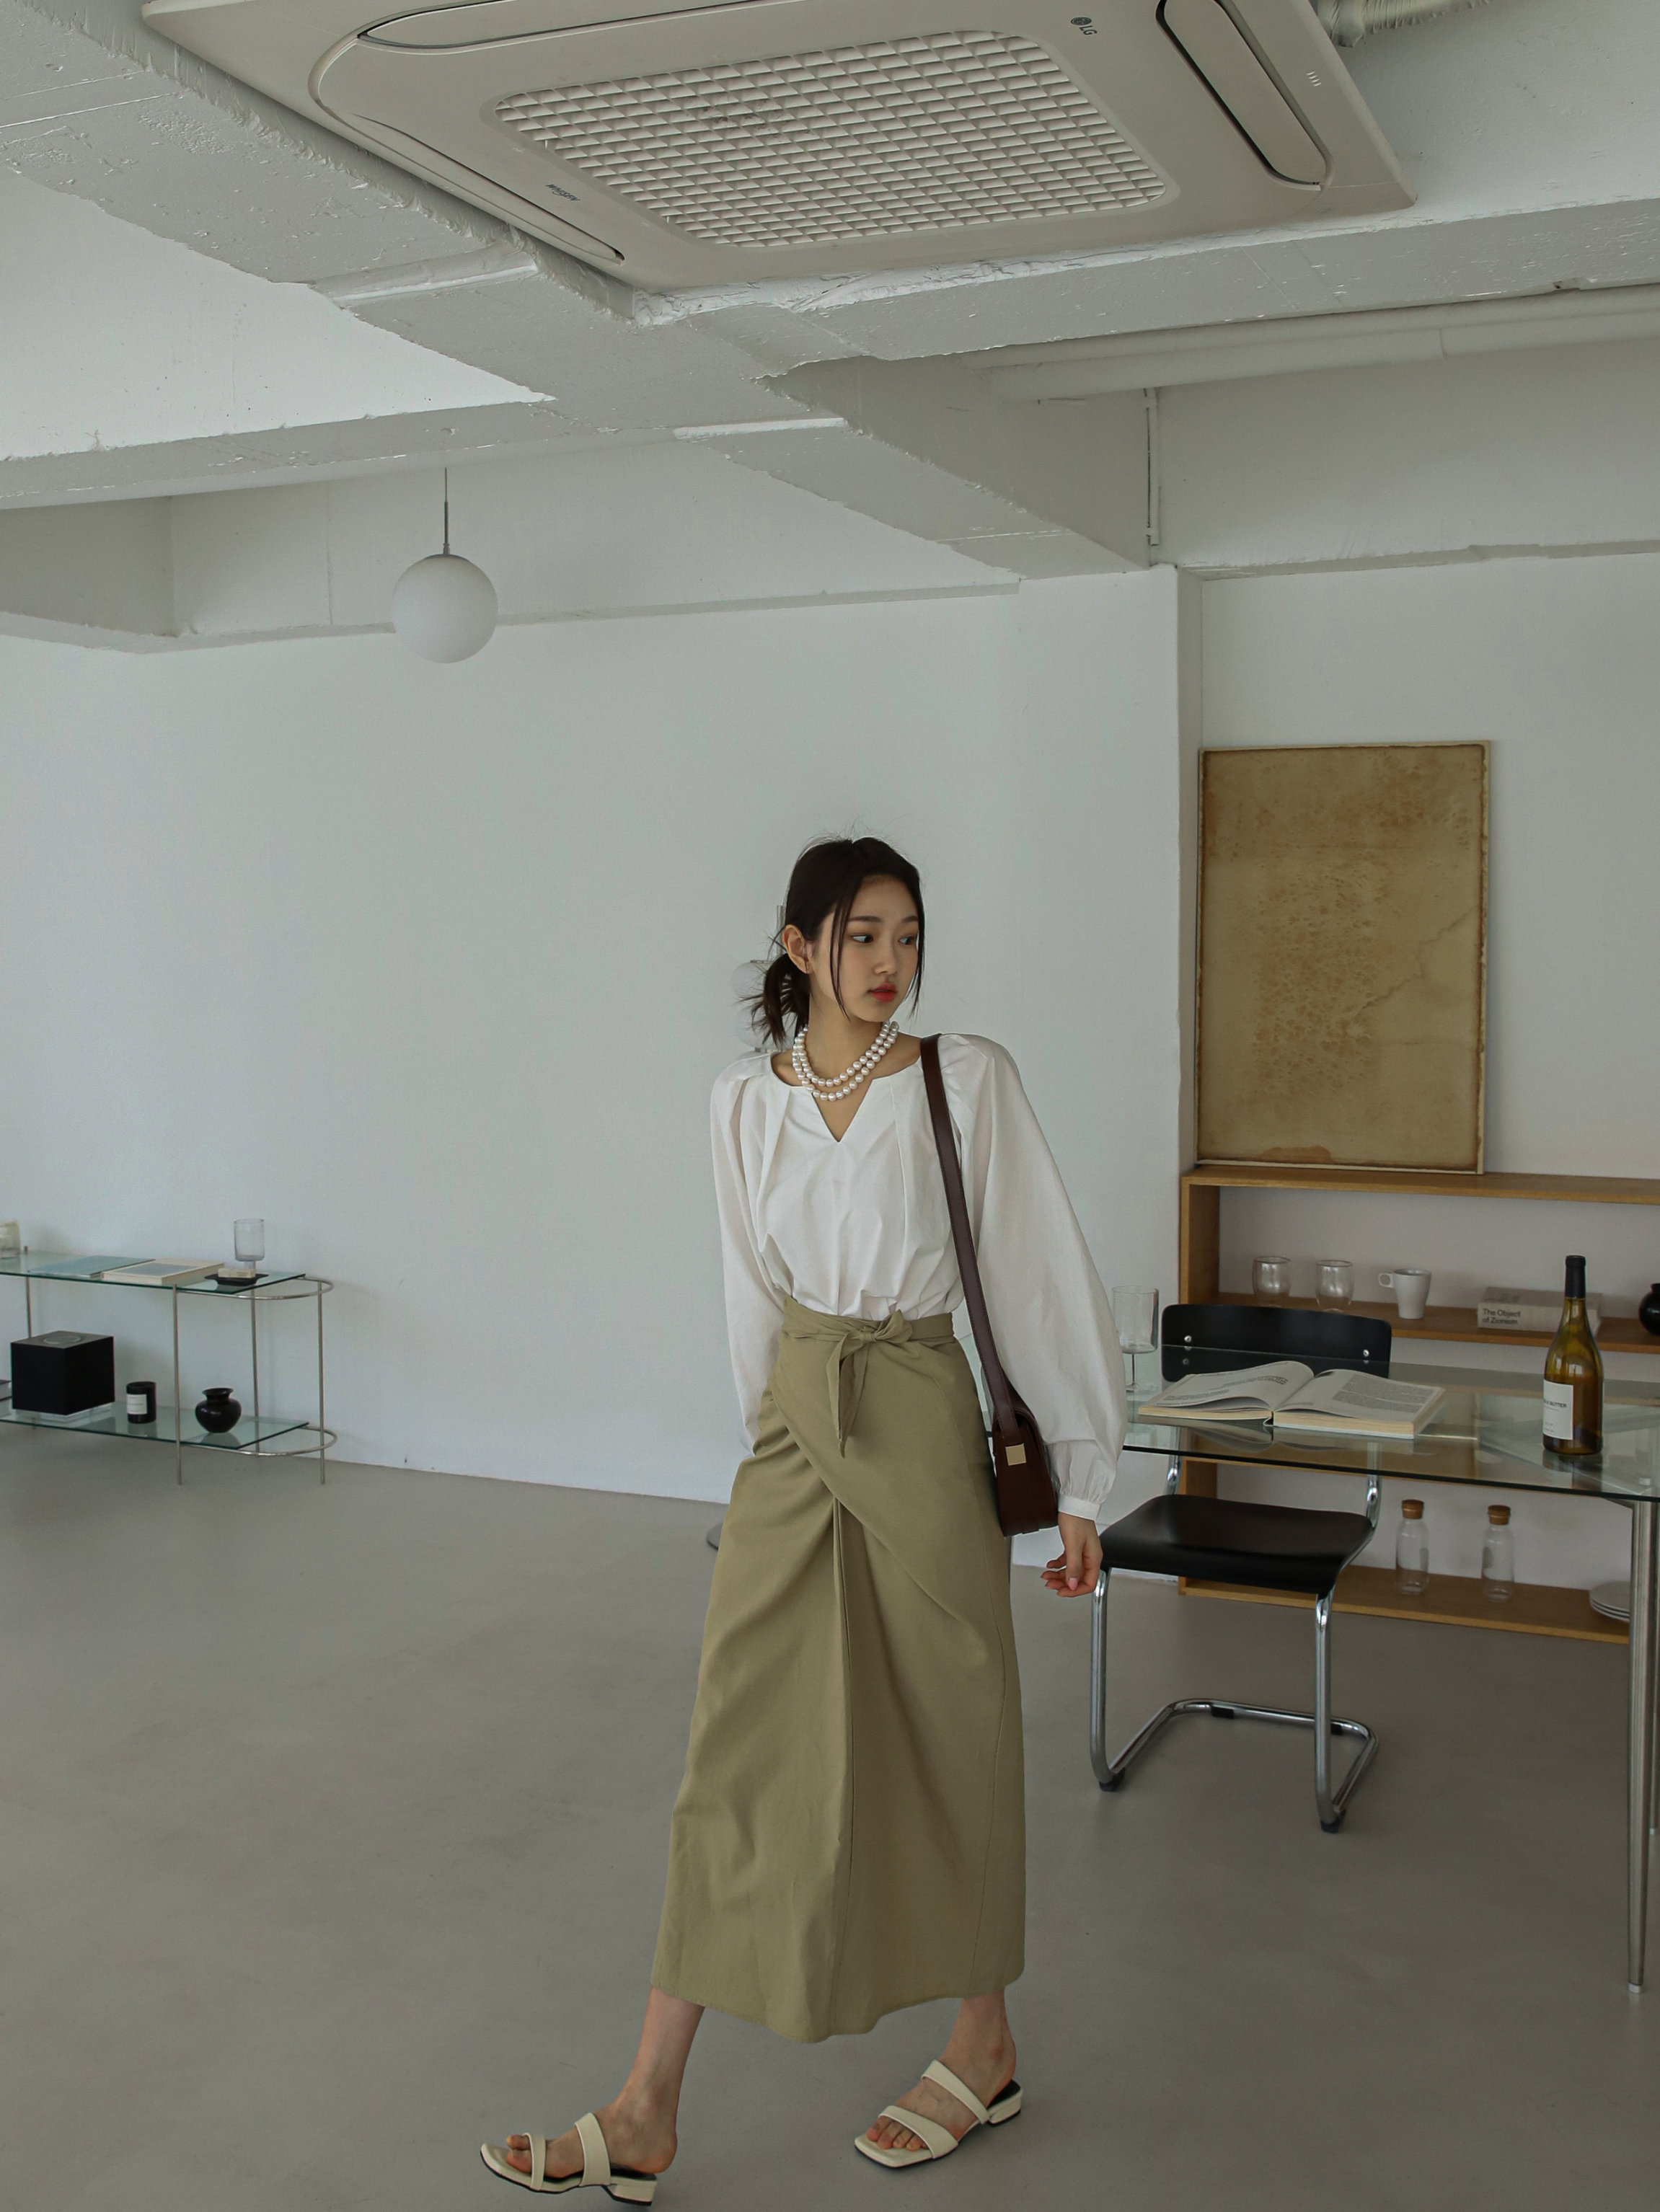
[1198,746,1488,1170]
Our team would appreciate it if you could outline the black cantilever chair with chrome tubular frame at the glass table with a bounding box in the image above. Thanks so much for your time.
[1089,1305,1390,1833]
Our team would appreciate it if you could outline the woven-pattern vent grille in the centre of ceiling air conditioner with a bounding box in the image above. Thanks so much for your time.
[496,31,1164,248]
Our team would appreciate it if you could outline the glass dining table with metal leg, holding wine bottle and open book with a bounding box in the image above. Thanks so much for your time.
[1124,1352,1660,1991]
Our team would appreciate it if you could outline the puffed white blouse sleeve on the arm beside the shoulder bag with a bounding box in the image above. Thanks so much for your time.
[940,1038,1126,1520]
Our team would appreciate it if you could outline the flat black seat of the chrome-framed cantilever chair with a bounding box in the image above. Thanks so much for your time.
[1100,1493,1372,1597]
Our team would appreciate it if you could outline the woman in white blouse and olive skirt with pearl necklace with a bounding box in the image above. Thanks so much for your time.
[485,839,1124,2203]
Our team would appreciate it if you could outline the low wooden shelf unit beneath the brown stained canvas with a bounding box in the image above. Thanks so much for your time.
[1180,1164,1660,1644]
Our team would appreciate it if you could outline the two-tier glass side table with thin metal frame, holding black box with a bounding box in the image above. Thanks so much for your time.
[0,1249,334,1482]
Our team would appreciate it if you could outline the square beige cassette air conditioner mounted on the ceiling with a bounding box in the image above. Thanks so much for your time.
[144,0,1412,288]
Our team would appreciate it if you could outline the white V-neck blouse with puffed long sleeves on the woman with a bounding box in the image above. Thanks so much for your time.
[710,1038,1124,1520]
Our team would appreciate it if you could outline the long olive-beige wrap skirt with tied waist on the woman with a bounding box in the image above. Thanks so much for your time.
[650,1301,1025,2042]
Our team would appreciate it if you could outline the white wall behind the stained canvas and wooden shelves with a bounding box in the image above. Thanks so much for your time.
[1204,555,1660,1584]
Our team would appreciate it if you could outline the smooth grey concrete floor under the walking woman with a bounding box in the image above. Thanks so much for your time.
[0,1429,1660,2212]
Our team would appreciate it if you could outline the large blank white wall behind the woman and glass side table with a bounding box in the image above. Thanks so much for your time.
[0,573,1182,1497]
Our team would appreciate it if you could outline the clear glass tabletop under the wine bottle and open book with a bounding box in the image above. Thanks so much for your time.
[1124,1356,1660,1500]
